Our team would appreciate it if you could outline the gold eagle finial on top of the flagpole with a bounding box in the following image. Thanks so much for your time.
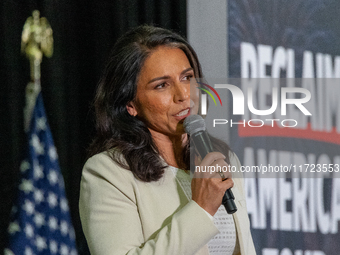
[21,10,53,81]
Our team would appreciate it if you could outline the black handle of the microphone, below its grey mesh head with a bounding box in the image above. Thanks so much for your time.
[192,131,237,214]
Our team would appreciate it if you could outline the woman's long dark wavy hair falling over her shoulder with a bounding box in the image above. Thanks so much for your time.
[89,26,229,182]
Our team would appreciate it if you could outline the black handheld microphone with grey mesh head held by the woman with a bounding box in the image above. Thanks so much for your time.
[183,115,237,214]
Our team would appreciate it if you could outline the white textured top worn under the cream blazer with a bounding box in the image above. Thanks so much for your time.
[169,166,240,255]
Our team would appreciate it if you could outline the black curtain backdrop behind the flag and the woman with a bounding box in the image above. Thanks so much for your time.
[0,0,186,254]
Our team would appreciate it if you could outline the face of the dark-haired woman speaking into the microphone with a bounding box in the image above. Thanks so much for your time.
[127,46,199,136]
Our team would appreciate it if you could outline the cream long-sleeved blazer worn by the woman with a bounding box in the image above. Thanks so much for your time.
[79,152,256,255]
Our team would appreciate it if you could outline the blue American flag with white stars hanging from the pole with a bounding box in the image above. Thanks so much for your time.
[5,93,77,255]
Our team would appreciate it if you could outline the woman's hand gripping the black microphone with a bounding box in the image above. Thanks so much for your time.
[191,152,234,216]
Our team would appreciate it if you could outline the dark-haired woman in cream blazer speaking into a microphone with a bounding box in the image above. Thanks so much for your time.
[80,26,255,255]
